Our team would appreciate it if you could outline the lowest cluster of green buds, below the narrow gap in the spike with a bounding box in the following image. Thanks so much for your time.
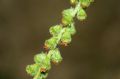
[26,48,62,79]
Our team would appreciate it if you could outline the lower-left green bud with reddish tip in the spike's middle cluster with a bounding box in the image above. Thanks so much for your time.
[45,37,58,49]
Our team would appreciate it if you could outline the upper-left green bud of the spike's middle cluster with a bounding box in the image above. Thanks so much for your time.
[49,25,62,36]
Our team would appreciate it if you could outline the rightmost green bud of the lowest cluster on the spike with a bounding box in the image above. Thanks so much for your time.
[51,49,62,64]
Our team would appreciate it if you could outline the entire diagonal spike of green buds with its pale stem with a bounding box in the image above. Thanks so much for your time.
[26,0,93,79]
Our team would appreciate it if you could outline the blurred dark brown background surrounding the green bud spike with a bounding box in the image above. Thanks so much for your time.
[0,0,120,79]
